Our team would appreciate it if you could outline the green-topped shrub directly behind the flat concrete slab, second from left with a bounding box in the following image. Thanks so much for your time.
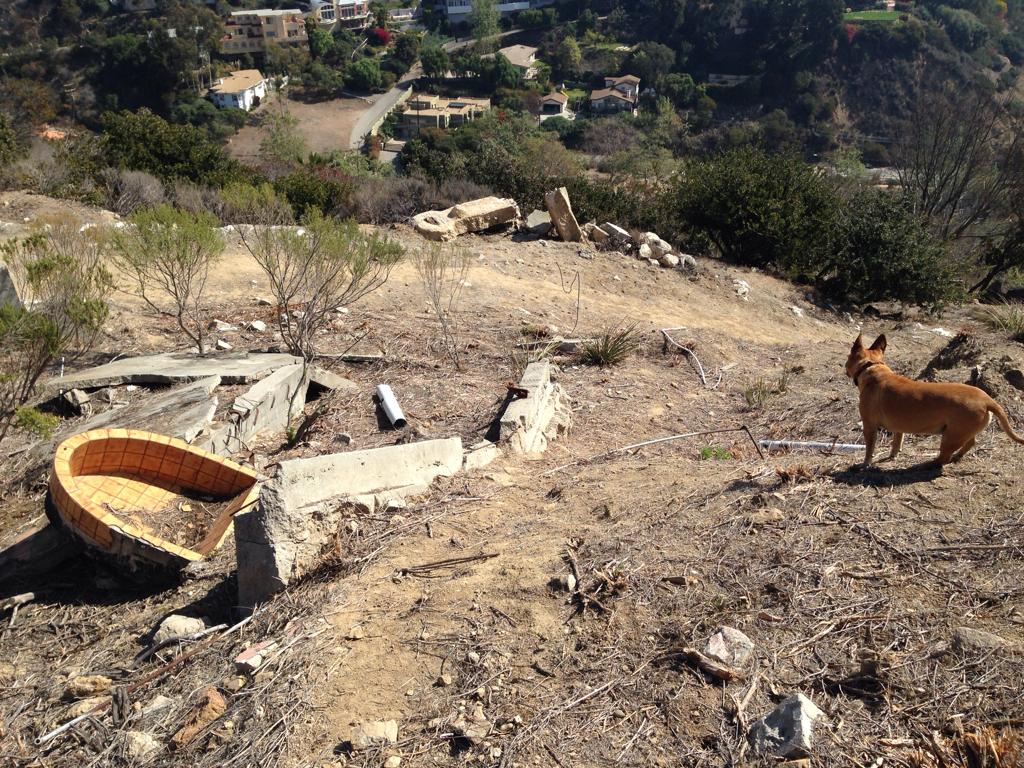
[112,205,224,353]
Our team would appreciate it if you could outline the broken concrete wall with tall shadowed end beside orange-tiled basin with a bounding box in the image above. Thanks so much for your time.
[234,437,463,607]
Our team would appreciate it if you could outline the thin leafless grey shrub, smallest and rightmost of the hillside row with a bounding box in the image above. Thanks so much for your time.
[415,243,473,371]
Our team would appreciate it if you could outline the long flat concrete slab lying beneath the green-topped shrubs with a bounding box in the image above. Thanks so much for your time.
[44,352,301,390]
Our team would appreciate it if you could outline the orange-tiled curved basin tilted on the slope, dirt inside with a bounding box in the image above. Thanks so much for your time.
[50,429,259,568]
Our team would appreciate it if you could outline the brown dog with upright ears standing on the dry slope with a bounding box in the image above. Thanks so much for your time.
[846,335,1024,467]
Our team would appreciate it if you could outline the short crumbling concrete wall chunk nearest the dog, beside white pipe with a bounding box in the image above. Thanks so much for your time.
[501,360,572,454]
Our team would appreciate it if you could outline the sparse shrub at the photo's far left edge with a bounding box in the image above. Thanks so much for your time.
[0,217,113,439]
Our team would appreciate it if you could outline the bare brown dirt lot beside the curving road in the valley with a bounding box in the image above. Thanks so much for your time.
[227,89,370,163]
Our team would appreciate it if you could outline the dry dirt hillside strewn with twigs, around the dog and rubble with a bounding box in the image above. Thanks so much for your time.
[0,188,1024,768]
